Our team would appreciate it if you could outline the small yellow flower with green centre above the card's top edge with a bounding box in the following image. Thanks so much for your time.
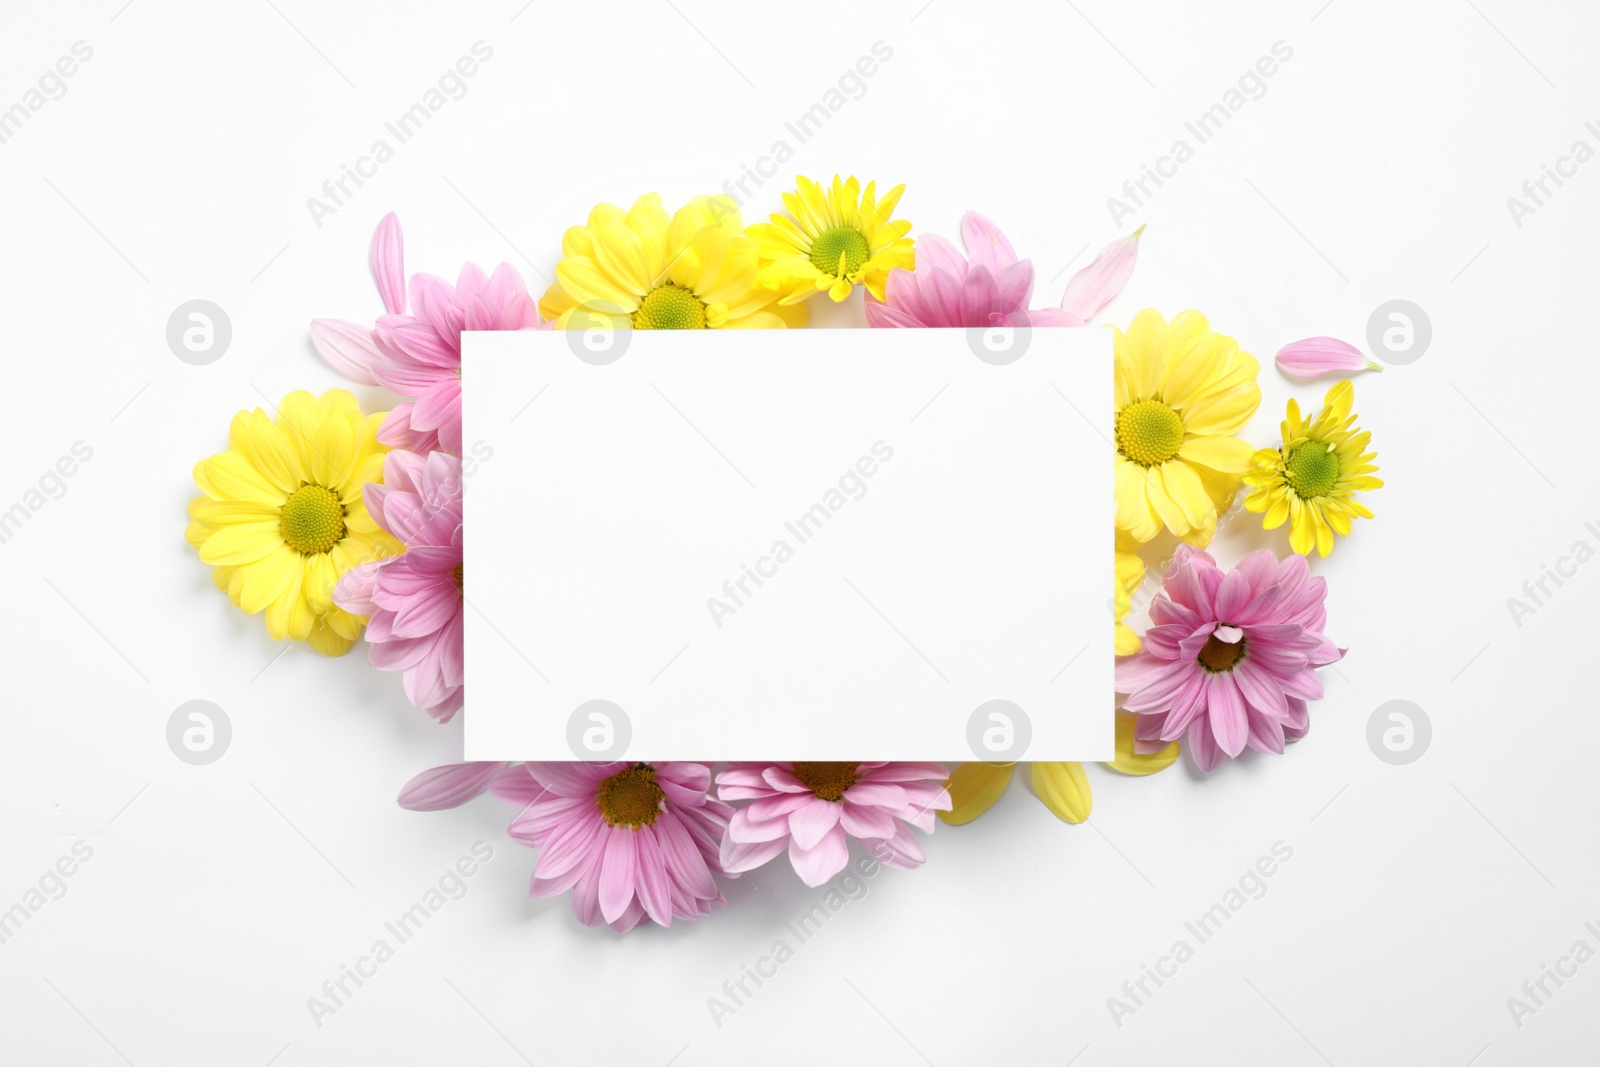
[747,174,915,304]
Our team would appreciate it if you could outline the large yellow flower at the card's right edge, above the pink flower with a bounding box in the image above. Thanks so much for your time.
[1114,309,1261,547]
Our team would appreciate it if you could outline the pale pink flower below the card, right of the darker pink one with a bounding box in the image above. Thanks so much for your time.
[717,761,950,886]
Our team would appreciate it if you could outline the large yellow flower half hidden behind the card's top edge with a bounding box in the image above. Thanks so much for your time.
[539,192,805,330]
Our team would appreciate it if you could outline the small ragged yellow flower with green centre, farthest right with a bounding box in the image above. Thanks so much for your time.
[1245,382,1382,555]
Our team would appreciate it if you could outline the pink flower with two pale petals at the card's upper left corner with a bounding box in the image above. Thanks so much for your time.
[310,213,539,454]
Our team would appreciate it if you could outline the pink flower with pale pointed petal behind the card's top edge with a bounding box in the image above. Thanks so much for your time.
[866,211,1144,328]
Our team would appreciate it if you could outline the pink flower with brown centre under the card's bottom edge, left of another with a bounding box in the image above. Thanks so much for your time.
[491,763,733,931]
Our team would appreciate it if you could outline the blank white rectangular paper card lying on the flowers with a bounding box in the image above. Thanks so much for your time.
[462,328,1114,763]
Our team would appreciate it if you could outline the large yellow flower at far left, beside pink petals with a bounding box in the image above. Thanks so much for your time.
[184,389,405,656]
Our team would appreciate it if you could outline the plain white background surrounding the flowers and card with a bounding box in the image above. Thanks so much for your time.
[0,0,1600,1067]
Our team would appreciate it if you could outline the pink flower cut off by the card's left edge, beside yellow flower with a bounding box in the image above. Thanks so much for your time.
[333,451,464,721]
